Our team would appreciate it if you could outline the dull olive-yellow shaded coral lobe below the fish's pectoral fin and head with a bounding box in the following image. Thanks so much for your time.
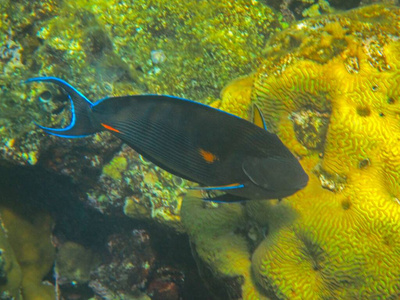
[182,194,265,300]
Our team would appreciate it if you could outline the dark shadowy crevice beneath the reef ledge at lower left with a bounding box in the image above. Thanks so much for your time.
[0,161,216,300]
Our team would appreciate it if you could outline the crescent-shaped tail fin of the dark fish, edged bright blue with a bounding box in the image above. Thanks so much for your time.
[25,77,101,138]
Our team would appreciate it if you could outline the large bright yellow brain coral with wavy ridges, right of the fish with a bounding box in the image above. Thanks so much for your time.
[182,5,400,299]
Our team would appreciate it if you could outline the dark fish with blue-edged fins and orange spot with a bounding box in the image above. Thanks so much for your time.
[27,77,308,202]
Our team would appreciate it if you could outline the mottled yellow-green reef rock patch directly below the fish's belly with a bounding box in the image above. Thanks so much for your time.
[88,145,187,232]
